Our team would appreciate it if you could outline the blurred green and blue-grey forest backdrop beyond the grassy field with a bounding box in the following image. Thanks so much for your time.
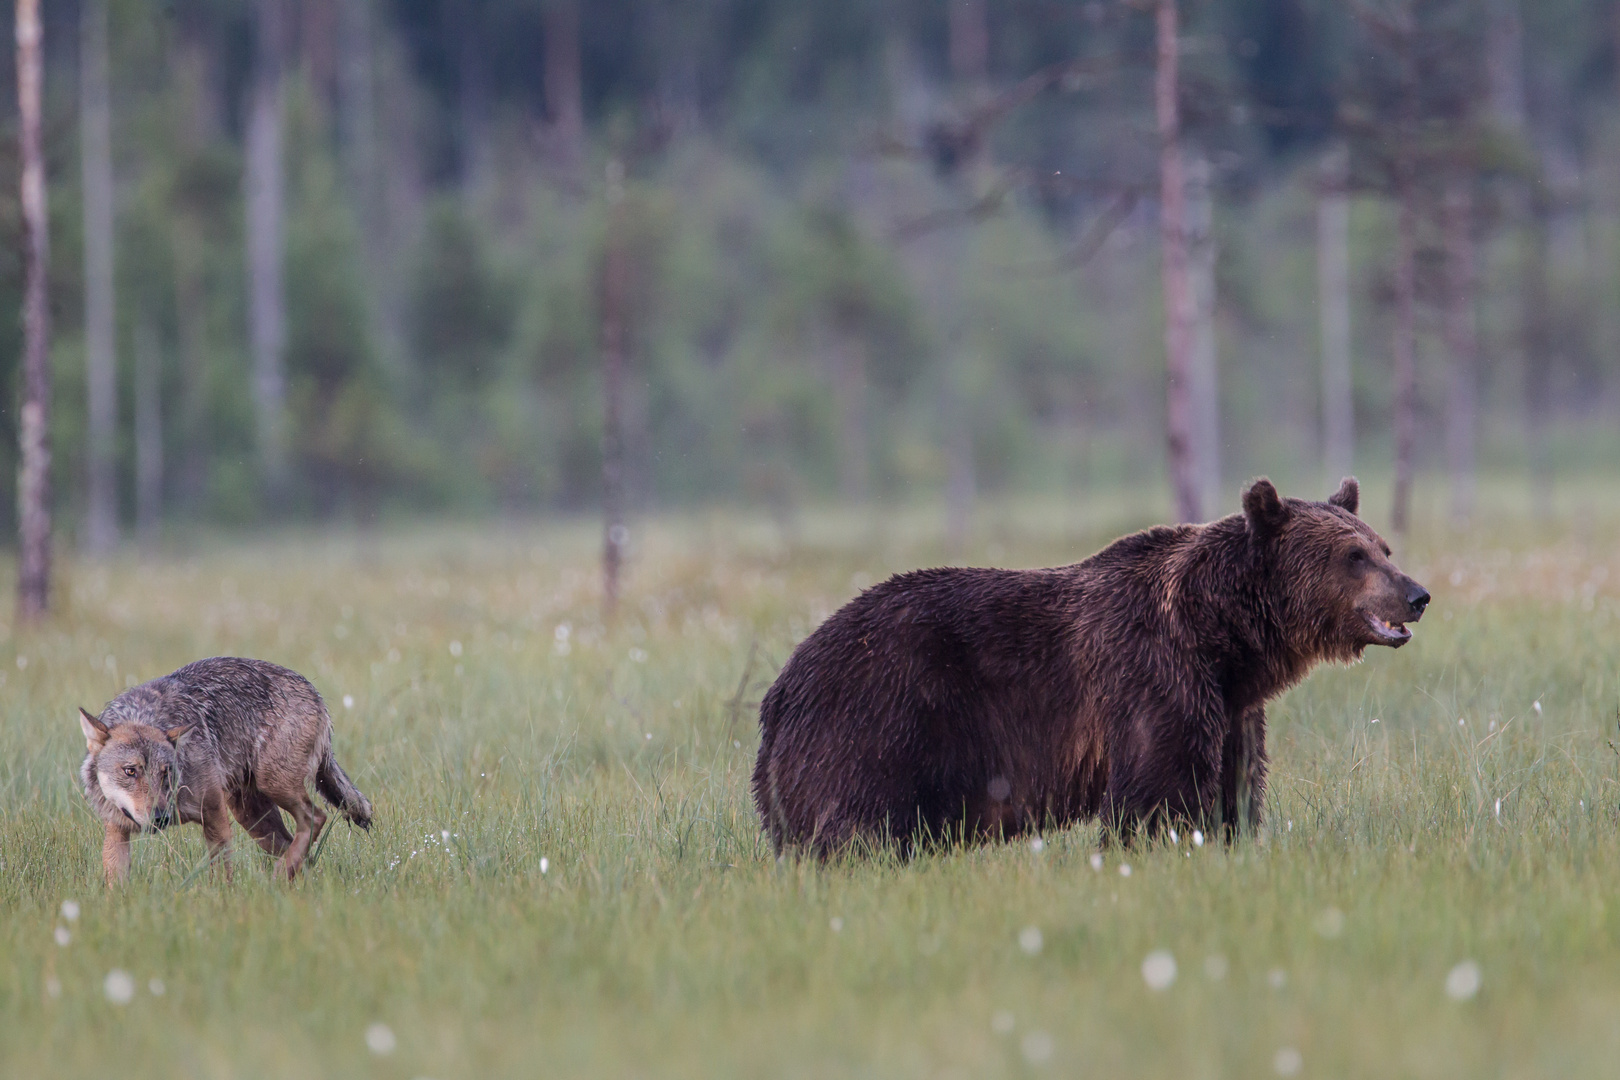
[0,0,1620,549]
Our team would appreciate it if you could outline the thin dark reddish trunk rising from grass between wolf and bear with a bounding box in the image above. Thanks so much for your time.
[601,159,630,619]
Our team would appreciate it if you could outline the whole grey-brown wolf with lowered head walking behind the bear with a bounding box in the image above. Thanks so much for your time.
[79,656,371,881]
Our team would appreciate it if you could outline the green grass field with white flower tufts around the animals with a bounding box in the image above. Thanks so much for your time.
[0,489,1620,1080]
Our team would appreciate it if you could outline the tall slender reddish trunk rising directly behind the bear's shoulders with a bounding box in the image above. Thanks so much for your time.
[1153,0,1204,521]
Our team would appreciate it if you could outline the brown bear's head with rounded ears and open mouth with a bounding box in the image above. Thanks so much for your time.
[1243,476,1429,661]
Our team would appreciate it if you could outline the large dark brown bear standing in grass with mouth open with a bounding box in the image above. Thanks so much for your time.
[753,478,1429,855]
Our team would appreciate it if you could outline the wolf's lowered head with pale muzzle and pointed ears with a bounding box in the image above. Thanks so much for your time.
[79,709,191,832]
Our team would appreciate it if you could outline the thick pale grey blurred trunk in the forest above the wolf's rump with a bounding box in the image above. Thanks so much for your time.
[243,0,288,505]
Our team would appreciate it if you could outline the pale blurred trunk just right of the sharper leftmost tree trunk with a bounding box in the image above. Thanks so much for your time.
[79,0,118,555]
